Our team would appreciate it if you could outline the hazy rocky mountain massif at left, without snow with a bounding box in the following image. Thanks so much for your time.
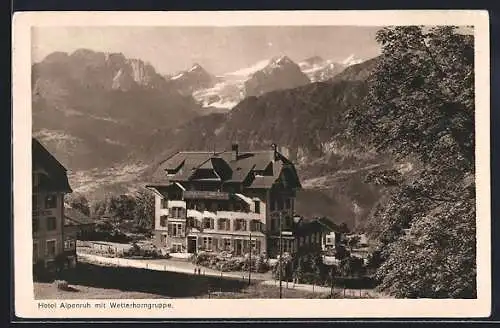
[32,49,199,170]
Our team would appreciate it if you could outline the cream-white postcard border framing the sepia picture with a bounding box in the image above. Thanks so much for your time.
[12,10,491,319]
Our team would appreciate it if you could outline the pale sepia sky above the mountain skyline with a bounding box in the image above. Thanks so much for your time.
[32,26,380,74]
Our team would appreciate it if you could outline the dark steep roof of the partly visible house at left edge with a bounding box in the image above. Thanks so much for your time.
[31,138,72,193]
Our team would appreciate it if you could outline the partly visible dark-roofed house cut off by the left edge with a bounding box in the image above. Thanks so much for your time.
[32,138,76,271]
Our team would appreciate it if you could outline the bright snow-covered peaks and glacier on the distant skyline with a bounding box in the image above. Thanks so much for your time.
[172,55,362,111]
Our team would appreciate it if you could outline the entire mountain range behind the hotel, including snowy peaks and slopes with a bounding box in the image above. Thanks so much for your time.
[32,49,393,226]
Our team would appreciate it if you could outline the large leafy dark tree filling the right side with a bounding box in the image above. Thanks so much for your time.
[348,26,476,298]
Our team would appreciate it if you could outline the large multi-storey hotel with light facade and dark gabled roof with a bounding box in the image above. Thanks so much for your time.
[147,144,301,257]
